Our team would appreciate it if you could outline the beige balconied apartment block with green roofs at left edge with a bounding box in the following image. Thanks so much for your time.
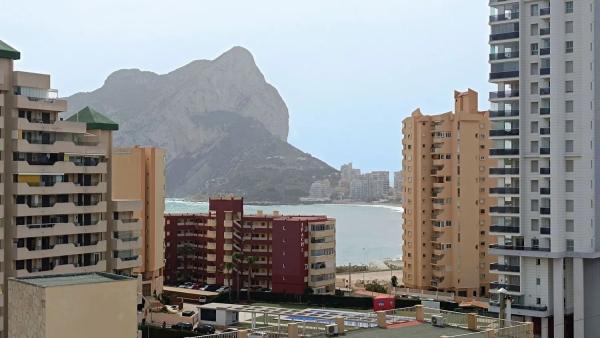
[0,41,141,336]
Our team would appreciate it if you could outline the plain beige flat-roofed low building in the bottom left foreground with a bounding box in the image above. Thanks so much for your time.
[8,272,137,338]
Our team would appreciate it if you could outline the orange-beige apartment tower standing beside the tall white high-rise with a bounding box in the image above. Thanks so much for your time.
[402,90,495,298]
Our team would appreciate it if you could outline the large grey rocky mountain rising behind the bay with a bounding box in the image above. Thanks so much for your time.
[67,47,337,202]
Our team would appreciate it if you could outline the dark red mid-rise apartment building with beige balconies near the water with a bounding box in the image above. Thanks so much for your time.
[165,198,335,294]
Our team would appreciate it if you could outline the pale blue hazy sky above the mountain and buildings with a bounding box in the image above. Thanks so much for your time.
[0,0,488,170]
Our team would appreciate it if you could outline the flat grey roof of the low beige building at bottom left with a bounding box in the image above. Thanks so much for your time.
[11,272,133,288]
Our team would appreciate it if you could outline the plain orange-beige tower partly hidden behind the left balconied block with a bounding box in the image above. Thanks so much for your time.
[112,146,165,296]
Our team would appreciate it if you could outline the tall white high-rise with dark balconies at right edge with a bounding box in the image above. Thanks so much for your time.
[489,0,600,338]
